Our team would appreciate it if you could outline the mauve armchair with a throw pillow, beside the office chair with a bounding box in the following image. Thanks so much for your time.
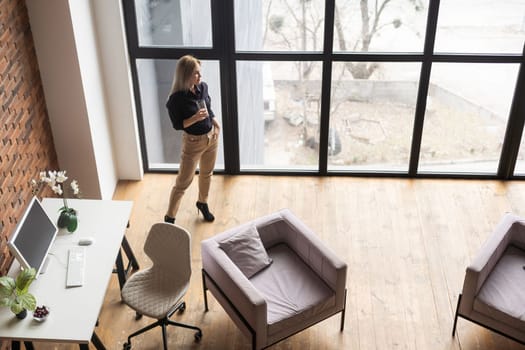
[201,209,347,350]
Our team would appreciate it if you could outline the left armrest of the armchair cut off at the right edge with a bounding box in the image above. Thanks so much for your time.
[461,214,525,311]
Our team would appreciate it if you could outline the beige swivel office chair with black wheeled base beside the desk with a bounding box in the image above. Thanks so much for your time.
[121,223,202,350]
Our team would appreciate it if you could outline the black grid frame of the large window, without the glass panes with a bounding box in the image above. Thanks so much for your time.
[122,0,525,180]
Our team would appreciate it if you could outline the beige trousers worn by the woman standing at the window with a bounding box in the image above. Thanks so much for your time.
[166,130,218,218]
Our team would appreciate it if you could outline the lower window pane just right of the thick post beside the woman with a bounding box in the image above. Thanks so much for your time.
[237,61,321,170]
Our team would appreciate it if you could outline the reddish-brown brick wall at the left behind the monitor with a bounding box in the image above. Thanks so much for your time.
[0,0,58,274]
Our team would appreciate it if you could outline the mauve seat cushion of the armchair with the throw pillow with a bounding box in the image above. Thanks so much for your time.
[250,243,335,335]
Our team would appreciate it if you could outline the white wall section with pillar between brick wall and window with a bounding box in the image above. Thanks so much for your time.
[26,0,143,199]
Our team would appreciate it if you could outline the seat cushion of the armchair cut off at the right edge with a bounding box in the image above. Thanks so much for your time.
[473,245,525,329]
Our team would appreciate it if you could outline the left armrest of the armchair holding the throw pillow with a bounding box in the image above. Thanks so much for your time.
[201,238,267,339]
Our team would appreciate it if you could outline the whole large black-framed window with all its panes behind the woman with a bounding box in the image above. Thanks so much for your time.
[123,0,525,178]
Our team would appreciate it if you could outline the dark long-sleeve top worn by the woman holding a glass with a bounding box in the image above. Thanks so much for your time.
[166,82,215,135]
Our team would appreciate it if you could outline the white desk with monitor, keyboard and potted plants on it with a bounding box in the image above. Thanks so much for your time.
[0,198,133,349]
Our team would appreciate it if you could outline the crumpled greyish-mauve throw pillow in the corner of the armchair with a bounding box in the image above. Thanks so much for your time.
[219,226,272,278]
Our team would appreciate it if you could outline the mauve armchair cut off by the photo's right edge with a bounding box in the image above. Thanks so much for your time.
[452,214,525,344]
